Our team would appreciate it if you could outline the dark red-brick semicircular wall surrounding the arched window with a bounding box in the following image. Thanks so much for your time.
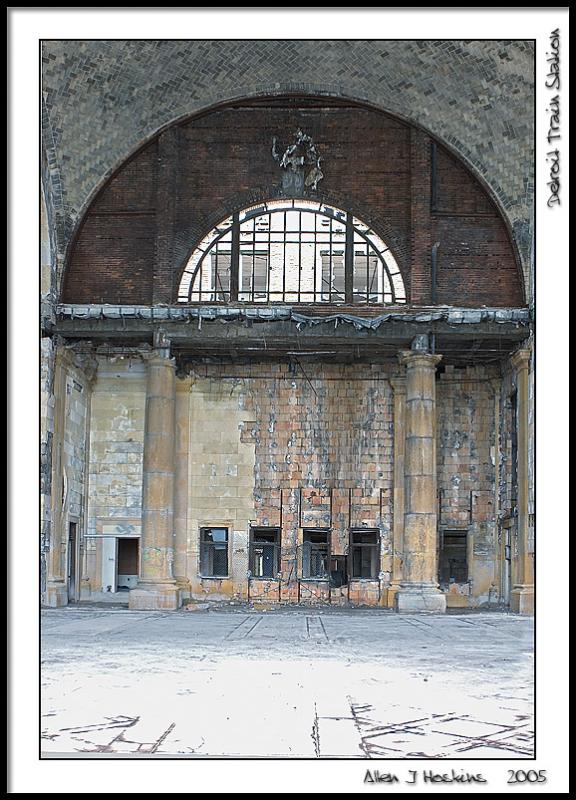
[62,95,524,306]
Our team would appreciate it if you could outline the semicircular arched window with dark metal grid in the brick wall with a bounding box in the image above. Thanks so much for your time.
[178,200,406,305]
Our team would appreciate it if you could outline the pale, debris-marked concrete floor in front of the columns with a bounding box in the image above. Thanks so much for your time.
[42,607,533,759]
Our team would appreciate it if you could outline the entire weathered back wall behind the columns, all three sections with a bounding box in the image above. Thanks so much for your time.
[77,358,512,605]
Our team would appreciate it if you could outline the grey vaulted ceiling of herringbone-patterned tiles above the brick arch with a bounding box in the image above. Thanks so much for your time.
[42,40,534,294]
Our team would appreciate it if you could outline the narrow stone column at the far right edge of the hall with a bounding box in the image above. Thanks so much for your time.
[510,348,534,614]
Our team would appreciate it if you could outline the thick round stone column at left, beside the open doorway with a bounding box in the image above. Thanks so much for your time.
[129,347,179,610]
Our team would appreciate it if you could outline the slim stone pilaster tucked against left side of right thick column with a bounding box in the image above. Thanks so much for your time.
[388,375,406,607]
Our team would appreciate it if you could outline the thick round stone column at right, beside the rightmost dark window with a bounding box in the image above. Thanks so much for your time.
[395,337,446,612]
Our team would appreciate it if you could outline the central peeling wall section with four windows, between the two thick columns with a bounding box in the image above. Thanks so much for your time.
[188,363,393,604]
